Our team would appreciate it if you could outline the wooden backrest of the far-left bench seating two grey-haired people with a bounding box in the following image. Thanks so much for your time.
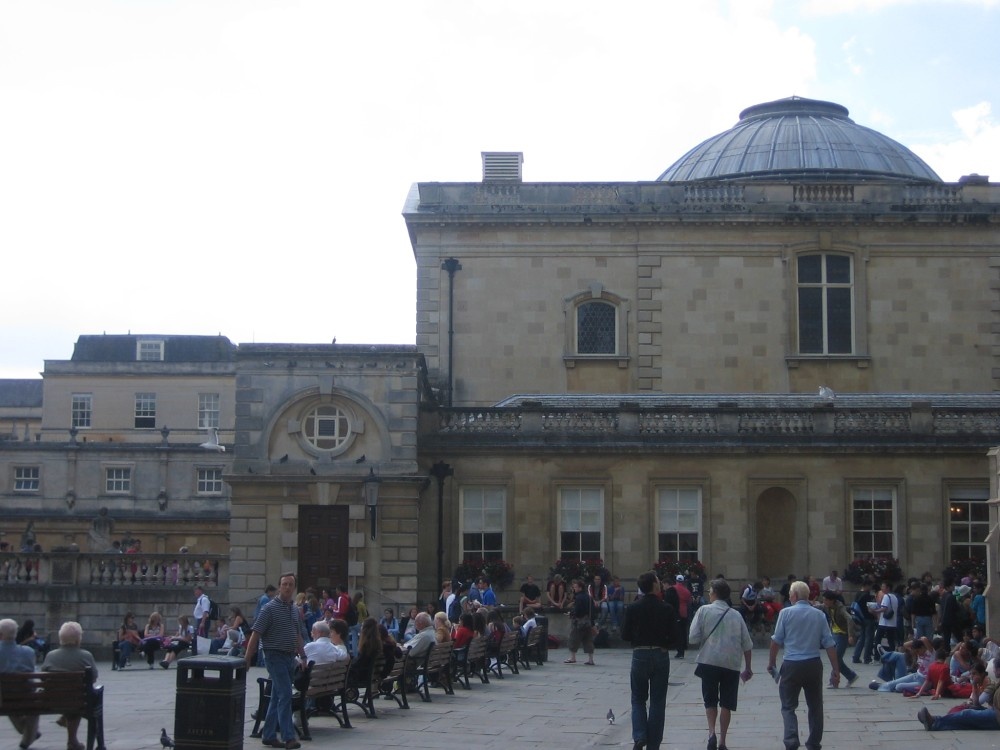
[0,669,100,715]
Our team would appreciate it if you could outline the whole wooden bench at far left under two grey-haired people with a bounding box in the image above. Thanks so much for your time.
[0,669,105,750]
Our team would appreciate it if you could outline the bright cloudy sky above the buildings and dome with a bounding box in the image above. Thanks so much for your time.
[0,0,1000,378]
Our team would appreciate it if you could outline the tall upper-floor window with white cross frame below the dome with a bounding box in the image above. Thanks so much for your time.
[798,253,854,354]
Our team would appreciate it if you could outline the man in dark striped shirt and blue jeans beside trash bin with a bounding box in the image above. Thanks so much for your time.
[244,573,305,750]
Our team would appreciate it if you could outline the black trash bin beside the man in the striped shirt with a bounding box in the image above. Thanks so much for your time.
[174,656,247,750]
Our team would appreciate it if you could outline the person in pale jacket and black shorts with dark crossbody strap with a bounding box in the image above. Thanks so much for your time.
[688,579,753,750]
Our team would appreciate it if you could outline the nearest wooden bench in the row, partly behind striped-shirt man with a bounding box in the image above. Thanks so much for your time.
[250,659,351,740]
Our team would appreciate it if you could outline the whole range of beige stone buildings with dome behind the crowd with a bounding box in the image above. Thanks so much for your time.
[0,98,1000,648]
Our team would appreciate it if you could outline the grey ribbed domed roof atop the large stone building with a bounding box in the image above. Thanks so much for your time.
[657,96,941,182]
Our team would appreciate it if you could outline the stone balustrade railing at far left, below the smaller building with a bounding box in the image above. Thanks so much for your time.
[0,552,229,588]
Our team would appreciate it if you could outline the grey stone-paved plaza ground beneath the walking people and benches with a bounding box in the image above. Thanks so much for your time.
[0,649,1000,750]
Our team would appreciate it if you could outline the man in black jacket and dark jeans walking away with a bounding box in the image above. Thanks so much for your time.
[622,571,677,750]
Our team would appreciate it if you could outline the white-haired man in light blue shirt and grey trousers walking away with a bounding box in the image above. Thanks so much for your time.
[767,581,840,750]
